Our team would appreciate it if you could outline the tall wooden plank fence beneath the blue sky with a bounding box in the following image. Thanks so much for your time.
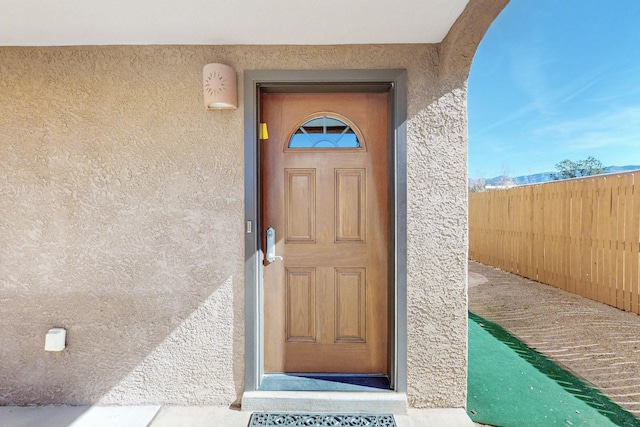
[469,171,640,314]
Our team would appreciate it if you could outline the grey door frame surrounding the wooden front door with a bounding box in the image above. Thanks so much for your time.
[244,69,407,393]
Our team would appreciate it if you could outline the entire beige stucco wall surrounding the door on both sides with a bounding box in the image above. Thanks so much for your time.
[0,0,510,407]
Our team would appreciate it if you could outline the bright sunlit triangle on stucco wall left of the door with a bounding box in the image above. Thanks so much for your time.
[99,277,244,404]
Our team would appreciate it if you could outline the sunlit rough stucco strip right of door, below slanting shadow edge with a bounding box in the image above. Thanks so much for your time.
[407,83,467,407]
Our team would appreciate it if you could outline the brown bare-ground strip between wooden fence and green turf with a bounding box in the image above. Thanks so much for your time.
[469,261,640,416]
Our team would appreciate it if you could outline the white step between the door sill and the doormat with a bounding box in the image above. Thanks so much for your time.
[242,390,407,415]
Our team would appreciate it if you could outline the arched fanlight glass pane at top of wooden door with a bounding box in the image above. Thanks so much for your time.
[289,116,361,148]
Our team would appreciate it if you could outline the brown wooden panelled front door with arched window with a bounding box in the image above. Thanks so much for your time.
[260,93,390,374]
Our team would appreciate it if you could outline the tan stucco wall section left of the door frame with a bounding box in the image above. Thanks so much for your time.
[0,47,244,405]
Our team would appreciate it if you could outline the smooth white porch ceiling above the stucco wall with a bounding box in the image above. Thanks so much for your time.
[0,0,469,46]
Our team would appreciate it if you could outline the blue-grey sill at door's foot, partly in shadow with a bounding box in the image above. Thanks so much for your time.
[260,373,393,392]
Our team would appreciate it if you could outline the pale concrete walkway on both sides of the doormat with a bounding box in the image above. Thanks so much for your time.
[0,405,473,427]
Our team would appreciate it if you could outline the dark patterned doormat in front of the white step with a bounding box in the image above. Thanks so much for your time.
[249,412,396,427]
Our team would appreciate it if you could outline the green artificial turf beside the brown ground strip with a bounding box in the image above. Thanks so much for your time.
[467,313,640,427]
